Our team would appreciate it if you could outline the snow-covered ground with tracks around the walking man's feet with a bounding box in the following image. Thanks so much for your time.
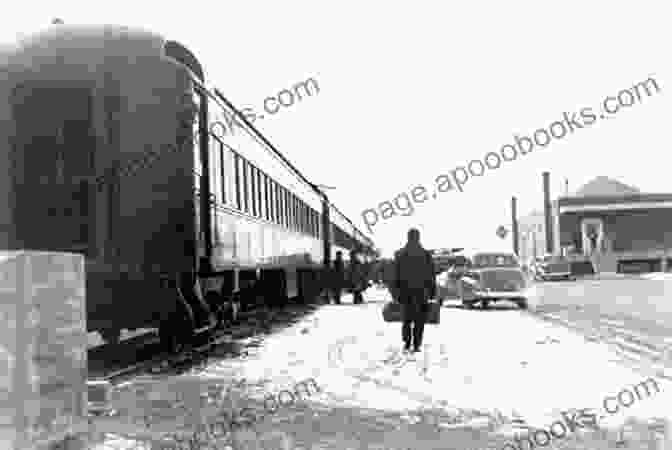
[80,282,672,450]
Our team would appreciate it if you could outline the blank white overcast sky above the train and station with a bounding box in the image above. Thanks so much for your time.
[0,0,672,254]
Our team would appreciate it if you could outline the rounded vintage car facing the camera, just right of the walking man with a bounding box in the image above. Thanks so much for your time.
[457,253,528,309]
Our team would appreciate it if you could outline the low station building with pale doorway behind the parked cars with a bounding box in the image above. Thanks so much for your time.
[519,176,672,273]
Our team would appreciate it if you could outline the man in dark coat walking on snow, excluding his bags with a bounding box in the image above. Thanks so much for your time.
[394,228,436,352]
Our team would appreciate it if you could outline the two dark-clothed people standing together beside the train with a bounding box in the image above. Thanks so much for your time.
[329,250,370,305]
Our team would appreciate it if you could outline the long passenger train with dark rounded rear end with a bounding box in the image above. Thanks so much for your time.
[0,24,373,342]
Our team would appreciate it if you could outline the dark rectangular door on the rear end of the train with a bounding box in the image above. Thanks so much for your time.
[12,83,96,255]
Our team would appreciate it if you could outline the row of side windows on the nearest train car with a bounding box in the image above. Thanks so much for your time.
[196,134,320,237]
